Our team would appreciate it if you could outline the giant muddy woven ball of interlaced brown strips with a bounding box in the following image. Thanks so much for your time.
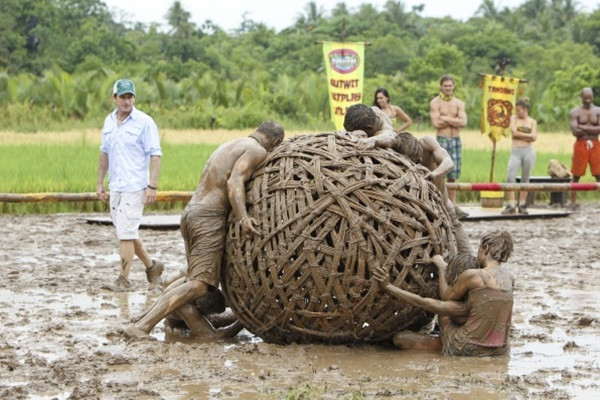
[222,132,456,343]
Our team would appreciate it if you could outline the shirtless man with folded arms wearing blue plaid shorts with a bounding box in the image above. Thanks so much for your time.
[429,75,468,219]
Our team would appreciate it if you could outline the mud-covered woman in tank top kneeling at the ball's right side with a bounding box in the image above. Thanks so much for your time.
[373,231,515,357]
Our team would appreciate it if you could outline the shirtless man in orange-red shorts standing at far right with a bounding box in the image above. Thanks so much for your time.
[569,87,600,210]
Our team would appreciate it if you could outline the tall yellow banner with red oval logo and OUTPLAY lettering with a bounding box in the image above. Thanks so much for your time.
[323,42,365,130]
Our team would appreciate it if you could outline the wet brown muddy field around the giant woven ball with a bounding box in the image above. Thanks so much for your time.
[0,203,600,400]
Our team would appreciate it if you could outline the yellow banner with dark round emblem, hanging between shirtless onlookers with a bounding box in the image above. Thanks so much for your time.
[481,75,519,142]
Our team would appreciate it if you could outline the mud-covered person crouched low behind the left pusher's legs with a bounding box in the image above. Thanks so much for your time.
[163,271,244,339]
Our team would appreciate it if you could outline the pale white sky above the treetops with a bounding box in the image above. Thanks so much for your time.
[104,0,548,31]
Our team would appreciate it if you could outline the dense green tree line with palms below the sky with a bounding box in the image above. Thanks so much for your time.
[0,0,600,131]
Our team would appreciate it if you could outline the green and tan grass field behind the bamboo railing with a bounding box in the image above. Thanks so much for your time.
[0,130,598,214]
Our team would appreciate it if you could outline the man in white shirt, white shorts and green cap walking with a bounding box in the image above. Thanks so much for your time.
[96,79,164,291]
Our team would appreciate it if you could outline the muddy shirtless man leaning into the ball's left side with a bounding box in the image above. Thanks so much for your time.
[124,121,284,338]
